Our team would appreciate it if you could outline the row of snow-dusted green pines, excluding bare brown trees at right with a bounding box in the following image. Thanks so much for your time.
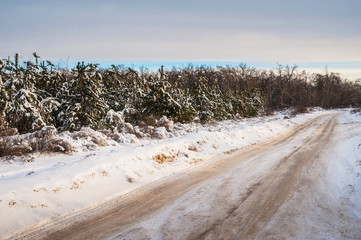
[0,53,264,133]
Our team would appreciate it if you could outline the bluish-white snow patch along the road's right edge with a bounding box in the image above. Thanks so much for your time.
[327,112,361,219]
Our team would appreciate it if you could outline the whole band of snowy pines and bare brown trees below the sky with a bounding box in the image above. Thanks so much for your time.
[0,53,361,135]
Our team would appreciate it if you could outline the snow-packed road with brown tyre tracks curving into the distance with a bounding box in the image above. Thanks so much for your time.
[3,113,361,239]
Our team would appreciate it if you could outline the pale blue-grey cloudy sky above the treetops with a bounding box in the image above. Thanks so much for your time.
[0,0,361,78]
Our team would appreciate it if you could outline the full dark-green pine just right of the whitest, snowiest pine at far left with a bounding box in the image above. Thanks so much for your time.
[57,62,108,131]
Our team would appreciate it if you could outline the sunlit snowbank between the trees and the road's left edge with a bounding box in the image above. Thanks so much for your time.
[0,111,328,236]
